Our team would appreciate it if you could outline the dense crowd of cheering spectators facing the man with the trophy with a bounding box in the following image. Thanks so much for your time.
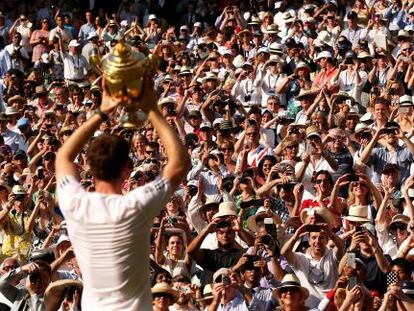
[0,0,414,311]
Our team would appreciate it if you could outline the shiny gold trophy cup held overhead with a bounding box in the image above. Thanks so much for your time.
[89,38,159,129]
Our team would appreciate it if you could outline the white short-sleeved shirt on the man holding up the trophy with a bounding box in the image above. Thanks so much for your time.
[57,176,172,311]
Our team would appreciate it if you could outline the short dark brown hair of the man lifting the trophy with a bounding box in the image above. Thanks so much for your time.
[87,134,130,181]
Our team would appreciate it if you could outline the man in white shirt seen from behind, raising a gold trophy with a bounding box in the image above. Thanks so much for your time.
[56,77,190,311]
